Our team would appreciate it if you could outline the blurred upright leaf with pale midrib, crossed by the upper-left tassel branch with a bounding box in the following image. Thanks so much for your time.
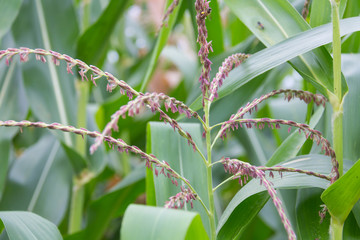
[9,0,78,146]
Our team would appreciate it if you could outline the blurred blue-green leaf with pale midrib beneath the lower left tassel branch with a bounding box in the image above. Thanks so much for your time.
[0,135,72,224]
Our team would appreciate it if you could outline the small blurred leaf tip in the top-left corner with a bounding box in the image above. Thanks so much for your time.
[0,0,23,42]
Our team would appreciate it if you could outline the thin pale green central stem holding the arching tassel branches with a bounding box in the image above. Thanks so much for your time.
[204,99,216,239]
